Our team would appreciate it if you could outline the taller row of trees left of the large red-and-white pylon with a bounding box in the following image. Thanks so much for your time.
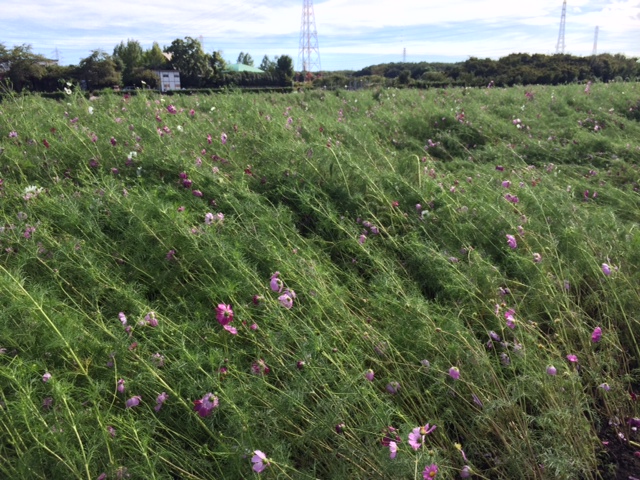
[0,37,294,92]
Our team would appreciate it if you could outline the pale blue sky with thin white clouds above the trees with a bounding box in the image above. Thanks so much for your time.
[0,0,640,71]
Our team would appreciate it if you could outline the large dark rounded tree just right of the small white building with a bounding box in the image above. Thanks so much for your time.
[164,37,211,87]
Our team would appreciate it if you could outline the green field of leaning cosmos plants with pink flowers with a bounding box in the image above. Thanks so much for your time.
[0,83,640,480]
